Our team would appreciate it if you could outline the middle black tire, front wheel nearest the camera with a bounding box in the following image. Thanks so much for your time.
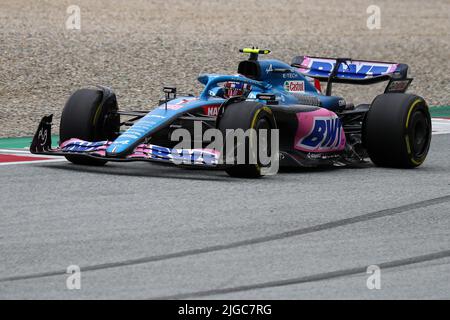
[217,101,276,178]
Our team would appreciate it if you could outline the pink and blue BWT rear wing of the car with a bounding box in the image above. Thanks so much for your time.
[291,56,412,95]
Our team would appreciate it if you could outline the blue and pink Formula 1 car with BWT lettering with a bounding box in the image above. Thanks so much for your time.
[30,48,431,177]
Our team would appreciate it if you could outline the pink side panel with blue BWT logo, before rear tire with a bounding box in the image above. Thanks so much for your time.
[294,108,346,152]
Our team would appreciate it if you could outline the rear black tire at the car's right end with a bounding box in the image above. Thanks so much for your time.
[363,93,431,168]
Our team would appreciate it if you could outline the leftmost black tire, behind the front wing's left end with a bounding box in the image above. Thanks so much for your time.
[59,89,120,166]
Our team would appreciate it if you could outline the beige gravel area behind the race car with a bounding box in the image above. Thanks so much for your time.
[0,0,450,137]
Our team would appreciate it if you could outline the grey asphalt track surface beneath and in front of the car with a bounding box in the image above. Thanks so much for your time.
[0,134,450,299]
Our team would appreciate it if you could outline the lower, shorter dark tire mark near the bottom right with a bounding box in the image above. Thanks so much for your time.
[150,250,450,300]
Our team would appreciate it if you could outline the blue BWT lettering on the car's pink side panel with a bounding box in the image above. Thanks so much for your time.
[297,116,342,151]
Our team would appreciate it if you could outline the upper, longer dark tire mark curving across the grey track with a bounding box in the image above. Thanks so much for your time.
[0,195,450,283]
